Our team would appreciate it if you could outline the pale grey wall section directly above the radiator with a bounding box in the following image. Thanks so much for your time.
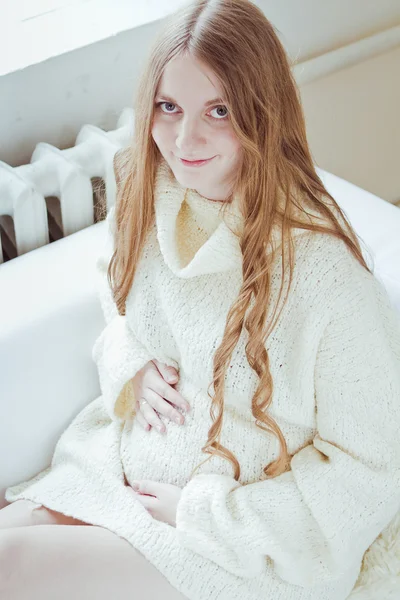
[0,21,161,166]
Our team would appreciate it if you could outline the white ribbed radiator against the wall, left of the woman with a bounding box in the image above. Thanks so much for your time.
[0,108,134,263]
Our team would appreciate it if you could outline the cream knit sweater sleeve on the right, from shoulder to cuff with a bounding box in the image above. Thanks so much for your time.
[176,263,400,588]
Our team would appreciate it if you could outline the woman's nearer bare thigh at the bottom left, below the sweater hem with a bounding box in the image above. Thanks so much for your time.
[0,525,185,600]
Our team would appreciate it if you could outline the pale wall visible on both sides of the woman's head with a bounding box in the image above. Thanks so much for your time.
[0,0,400,202]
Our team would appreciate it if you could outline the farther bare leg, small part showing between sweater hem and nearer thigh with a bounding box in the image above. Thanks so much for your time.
[0,500,88,529]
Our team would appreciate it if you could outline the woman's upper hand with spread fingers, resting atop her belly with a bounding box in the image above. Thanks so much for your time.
[132,359,190,433]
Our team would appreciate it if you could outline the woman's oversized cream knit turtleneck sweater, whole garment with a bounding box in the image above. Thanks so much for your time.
[6,162,400,600]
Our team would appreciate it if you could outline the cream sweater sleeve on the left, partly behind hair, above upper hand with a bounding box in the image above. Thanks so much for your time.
[92,206,153,423]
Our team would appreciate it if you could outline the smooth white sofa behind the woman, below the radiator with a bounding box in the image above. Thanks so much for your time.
[0,170,400,507]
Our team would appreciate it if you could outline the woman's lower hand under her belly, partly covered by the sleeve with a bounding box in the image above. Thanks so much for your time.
[128,479,182,527]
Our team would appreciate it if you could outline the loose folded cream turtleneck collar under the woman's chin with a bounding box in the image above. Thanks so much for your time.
[154,158,243,279]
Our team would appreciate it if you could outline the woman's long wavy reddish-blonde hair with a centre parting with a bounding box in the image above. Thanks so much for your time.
[108,0,371,480]
